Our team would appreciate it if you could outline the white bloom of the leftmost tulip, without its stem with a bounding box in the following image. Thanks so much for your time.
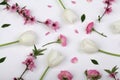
[19,30,37,46]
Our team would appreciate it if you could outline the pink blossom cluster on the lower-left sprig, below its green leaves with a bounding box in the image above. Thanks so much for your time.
[22,54,35,71]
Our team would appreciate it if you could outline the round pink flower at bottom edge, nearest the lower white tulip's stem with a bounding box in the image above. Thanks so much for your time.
[58,71,73,80]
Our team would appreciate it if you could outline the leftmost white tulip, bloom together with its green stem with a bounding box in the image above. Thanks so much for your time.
[0,30,37,47]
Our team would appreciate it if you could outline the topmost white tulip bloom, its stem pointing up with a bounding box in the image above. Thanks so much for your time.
[63,9,78,23]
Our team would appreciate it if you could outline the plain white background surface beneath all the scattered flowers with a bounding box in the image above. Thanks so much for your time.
[0,0,120,80]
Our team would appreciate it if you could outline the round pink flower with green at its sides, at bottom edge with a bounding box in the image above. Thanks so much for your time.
[85,70,101,79]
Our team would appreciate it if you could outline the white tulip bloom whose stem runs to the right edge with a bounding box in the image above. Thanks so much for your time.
[80,39,99,53]
